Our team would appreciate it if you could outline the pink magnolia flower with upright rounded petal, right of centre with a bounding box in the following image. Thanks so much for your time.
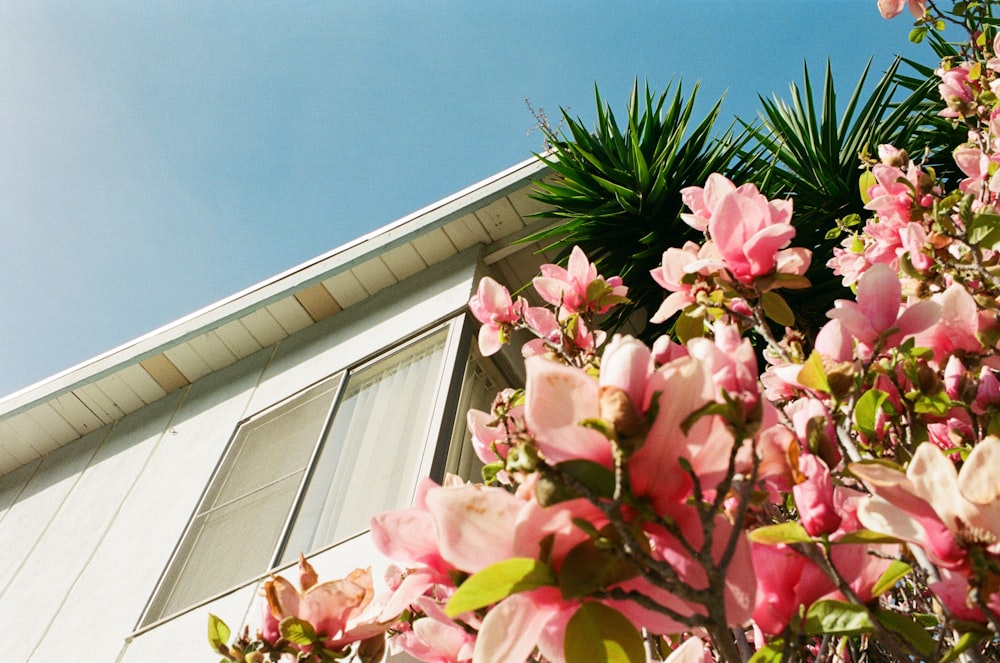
[827,264,941,356]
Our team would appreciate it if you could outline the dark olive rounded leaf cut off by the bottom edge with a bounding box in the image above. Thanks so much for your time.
[563,601,646,663]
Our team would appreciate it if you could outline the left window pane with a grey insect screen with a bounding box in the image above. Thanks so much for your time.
[144,376,341,624]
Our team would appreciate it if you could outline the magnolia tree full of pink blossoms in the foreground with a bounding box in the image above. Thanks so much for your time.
[210,0,1000,663]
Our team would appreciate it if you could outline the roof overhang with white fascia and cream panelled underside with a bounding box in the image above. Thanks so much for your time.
[0,159,551,474]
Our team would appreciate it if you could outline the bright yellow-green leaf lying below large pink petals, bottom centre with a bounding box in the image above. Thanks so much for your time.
[445,557,555,617]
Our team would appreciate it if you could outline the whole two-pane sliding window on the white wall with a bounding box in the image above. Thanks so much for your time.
[143,328,448,624]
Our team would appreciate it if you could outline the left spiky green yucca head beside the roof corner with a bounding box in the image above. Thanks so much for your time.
[525,83,748,340]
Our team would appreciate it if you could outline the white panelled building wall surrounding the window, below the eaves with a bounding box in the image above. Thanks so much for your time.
[0,250,478,663]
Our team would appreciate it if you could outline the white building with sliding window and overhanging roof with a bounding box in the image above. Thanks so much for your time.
[0,160,547,663]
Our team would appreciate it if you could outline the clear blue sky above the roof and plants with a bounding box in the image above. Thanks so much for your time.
[0,0,928,396]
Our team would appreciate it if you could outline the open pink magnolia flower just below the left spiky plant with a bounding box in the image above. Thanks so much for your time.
[532,246,628,314]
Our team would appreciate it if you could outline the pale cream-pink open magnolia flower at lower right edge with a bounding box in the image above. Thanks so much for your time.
[851,436,1000,572]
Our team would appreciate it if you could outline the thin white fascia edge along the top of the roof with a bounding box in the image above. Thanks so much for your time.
[0,157,549,417]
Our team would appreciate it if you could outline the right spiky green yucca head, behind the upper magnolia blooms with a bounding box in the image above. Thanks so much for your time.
[742,60,964,331]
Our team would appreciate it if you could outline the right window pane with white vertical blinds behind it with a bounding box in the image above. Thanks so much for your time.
[283,330,447,561]
